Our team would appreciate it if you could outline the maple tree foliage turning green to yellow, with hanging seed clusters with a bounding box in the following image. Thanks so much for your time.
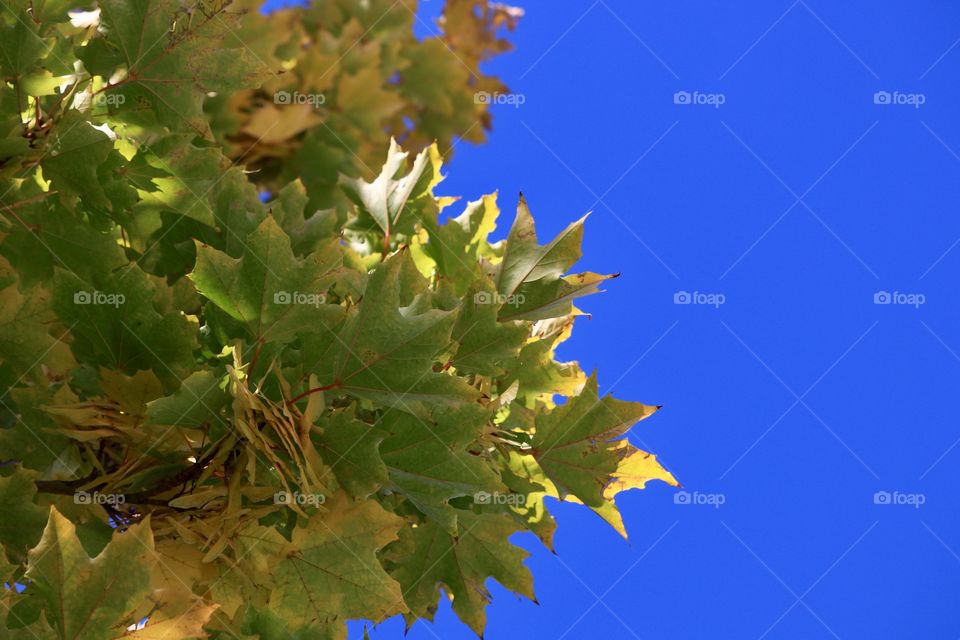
[0,0,676,640]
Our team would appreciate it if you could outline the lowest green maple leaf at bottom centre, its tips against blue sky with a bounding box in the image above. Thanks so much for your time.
[385,511,535,635]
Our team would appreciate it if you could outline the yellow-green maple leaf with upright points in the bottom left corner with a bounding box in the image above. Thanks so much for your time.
[27,507,154,640]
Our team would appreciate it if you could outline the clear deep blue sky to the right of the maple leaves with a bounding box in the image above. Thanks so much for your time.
[266,0,960,640]
